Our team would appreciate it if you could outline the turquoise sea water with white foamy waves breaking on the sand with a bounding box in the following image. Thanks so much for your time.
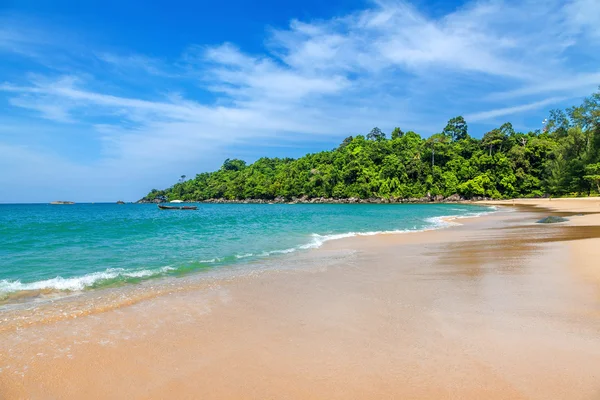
[0,204,490,296]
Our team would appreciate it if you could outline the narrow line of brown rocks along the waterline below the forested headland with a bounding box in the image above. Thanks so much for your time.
[138,194,474,204]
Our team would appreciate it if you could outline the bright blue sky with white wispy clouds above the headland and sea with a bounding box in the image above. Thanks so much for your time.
[0,0,600,203]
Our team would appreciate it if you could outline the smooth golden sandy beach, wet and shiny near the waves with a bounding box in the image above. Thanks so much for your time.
[0,199,600,399]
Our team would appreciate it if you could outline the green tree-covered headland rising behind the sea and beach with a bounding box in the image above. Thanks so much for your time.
[141,88,600,201]
